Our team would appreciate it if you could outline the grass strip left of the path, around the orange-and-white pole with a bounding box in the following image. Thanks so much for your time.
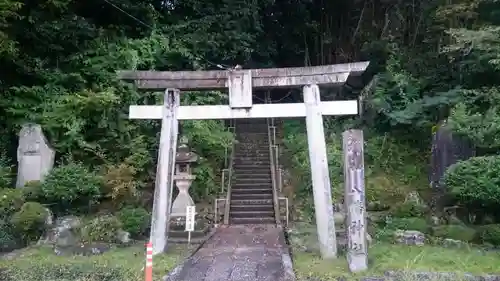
[0,245,189,281]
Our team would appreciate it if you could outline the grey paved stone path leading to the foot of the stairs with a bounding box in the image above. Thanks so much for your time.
[165,225,295,281]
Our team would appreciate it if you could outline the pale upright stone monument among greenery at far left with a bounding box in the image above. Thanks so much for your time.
[16,124,55,187]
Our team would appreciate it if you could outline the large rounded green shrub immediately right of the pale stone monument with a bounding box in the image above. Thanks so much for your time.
[40,163,101,215]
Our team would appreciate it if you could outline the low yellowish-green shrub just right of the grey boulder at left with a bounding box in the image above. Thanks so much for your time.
[81,215,122,243]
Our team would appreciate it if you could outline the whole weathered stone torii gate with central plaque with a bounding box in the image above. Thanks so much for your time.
[118,62,369,258]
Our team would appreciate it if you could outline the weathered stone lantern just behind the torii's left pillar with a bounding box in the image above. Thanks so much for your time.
[171,137,198,219]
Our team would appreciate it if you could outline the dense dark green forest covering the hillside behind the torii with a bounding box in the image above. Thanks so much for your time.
[0,0,500,245]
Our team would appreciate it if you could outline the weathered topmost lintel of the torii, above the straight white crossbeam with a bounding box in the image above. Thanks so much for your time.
[118,61,369,90]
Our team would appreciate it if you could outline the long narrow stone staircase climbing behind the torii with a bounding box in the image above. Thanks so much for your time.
[229,119,276,224]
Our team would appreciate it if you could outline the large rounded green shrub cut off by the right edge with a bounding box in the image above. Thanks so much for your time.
[444,153,500,212]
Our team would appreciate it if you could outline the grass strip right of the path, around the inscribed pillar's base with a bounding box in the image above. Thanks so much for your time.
[293,243,500,281]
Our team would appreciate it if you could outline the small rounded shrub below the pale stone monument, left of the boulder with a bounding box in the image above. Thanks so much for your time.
[10,202,49,242]
